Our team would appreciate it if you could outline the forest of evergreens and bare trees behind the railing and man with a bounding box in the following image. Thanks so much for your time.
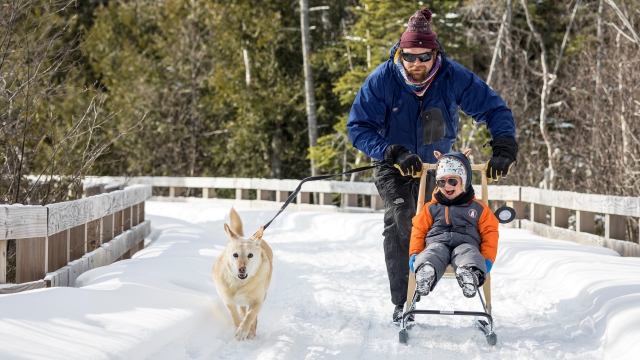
[0,0,640,205]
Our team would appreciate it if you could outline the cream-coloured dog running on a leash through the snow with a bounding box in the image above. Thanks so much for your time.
[213,208,273,341]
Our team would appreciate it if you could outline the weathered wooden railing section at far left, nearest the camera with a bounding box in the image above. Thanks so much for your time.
[0,185,151,294]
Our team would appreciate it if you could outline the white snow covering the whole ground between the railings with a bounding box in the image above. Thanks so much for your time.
[0,202,640,360]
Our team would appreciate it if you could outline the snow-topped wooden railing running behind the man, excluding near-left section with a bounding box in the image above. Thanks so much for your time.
[85,177,640,256]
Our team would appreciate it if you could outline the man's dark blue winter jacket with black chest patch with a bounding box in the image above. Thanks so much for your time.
[347,43,515,164]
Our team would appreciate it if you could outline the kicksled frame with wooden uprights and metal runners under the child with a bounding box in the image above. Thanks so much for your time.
[398,164,498,345]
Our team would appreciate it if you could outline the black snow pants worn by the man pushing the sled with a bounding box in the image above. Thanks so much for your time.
[373,162,435,305]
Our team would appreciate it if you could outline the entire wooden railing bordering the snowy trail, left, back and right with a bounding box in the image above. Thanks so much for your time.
[0,177,640,294]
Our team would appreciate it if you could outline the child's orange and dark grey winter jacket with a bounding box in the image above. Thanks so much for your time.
[409,196,498,263]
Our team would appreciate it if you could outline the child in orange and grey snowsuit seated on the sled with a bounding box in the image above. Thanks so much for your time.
[409,149,498,298]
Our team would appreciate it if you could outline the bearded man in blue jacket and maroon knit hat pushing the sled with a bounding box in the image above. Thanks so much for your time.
[347,8,518,322]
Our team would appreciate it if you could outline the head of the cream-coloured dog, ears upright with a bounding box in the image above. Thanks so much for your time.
[224,208,264,280]
